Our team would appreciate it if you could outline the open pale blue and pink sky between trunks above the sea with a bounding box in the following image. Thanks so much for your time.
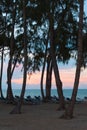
[3,0,87,89]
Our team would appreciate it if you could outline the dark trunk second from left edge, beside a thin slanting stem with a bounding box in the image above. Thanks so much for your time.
[7,2,16,102]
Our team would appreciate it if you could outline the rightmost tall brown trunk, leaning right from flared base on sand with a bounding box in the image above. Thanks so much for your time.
[62,0,84,119]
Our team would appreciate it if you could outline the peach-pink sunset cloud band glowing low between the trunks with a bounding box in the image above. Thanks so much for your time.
[12,68,87,88]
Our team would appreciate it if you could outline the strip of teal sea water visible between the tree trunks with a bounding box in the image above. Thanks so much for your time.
[3,89,87,99]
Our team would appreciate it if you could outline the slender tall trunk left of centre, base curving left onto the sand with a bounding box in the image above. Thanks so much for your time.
[10,0,27,114]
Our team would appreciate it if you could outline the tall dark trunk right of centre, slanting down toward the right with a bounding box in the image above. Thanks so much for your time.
[49,13,65,110]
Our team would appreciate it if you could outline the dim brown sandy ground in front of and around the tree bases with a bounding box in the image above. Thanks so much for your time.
[0,102,87,130]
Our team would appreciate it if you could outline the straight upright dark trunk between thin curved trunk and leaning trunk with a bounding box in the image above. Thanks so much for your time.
[46,57,52,99]
